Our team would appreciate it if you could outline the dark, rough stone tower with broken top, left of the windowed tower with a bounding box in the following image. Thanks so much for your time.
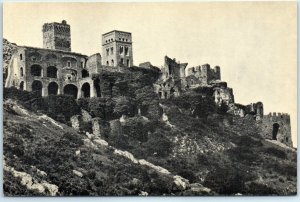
[43,20,71,51]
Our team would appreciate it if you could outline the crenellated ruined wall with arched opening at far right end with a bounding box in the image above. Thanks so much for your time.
[258,113,293,146]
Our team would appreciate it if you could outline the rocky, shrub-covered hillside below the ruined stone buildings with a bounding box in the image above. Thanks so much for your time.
[4,82,297,196]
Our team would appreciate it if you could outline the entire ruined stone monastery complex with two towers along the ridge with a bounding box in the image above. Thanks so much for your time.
[5,20,292,146]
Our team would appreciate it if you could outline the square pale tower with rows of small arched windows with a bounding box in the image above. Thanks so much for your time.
[102,30,133,67]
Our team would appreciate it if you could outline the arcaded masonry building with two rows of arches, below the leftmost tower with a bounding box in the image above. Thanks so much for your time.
[5,47,101,98]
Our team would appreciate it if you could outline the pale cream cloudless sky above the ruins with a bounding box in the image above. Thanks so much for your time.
[3,2,297,146]
